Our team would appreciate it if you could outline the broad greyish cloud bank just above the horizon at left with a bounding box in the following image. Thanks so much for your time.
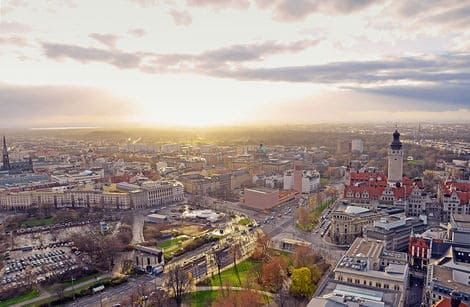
[0,83,132,127]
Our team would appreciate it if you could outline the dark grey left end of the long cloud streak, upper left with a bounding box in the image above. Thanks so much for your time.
[42,43,140,68]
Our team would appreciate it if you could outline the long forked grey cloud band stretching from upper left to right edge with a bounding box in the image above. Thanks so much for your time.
[39,40,470,105]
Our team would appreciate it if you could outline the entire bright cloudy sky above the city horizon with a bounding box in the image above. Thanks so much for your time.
[0,0,470,128]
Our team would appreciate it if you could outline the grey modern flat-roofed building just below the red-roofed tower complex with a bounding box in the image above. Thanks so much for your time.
[363,213,426,251]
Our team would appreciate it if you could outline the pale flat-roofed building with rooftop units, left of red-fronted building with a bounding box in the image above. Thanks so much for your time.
[334,238,409,306]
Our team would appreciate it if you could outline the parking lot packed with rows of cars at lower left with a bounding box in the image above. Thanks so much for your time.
[0,242,79,289]
